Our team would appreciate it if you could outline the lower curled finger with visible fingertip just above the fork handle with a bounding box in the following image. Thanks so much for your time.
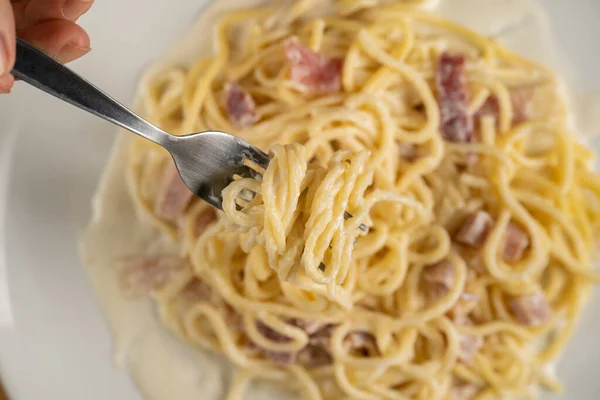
[17,19,90,63]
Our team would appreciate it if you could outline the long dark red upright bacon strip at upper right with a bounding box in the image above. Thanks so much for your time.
[435,52,475,143]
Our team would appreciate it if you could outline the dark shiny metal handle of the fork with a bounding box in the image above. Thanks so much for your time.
[11,39,173,146]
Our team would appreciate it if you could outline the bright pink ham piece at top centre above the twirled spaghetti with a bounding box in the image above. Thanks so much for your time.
[283,36,343,94]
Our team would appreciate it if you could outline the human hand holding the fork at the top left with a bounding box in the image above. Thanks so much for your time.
[0,0,93,93]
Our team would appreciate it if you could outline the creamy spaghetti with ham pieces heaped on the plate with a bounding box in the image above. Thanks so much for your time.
[122,0,600,400]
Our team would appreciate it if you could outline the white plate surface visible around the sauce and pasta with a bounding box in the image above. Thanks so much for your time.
[0,0,600,400]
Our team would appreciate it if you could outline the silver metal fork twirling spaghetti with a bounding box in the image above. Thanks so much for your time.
[11,39,367,231]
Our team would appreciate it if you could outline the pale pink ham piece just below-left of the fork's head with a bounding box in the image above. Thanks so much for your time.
[154,162,194,222]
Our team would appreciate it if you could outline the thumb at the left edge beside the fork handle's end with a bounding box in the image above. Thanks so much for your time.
[0,0,16,93]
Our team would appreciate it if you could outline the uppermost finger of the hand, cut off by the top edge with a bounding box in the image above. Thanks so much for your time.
[14,0,93,30]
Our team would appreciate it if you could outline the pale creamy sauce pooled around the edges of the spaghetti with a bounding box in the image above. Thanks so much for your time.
[81,0,600,400]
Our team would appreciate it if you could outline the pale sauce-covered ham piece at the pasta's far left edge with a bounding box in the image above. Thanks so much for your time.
[119,256,189,297]
